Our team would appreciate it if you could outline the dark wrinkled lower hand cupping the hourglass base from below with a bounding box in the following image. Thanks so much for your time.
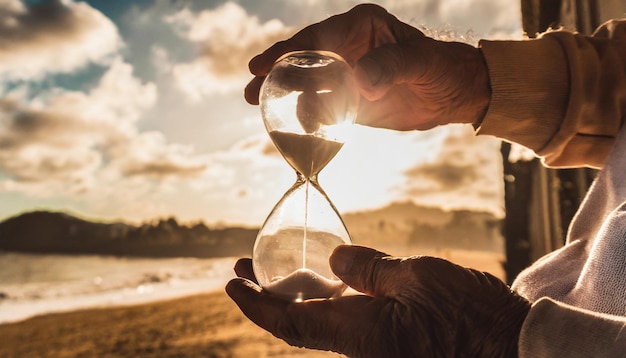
[226,246,530,357]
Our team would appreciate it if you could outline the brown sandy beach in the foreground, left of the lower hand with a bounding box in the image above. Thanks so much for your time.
[0,291,342,358]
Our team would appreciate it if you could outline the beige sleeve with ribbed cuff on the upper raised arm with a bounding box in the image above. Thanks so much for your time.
[477,20,626,167]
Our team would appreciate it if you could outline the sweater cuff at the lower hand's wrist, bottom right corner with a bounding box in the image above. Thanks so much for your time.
[519,298,626,358]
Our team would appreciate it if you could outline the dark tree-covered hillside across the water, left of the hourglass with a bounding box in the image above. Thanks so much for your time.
[0,211,257,257]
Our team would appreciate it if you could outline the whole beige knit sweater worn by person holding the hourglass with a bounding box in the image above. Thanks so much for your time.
[477,20,626,358]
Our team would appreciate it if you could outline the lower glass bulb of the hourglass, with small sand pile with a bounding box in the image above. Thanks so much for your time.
[252,181,351,301]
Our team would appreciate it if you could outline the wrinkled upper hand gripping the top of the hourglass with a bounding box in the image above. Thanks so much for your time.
[245,4,491,130]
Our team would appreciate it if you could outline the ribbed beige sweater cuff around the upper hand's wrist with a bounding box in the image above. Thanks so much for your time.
[477,38,569,152]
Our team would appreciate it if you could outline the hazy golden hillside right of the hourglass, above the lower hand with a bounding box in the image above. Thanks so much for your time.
[343,202,504,255]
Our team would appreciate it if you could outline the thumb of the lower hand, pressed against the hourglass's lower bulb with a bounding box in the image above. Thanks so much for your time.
[330,245,404,297]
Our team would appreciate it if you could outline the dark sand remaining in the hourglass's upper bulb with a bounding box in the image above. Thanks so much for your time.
[269,131,343,178]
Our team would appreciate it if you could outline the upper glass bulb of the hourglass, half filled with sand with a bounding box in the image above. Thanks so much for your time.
[259,51,359,178]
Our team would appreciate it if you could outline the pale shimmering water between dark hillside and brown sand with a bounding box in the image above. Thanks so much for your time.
[0,252,236,324]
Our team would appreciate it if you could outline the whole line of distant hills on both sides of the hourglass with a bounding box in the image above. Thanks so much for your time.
[0,202,503,257]
